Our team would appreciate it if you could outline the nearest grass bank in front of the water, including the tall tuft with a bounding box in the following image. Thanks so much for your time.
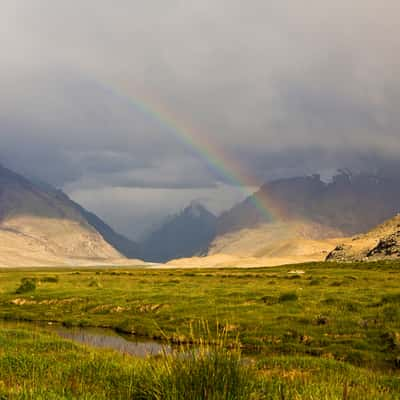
[0,328,400,400]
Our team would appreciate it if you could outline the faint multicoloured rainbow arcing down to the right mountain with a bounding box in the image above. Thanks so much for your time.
[96,84,281,221]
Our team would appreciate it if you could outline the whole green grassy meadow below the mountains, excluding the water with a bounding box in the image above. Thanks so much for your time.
[0,262,400,400]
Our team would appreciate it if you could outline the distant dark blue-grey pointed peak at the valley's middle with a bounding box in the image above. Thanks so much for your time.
[142,202,217,262]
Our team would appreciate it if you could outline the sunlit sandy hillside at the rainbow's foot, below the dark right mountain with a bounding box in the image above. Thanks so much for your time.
[167,221,343,267]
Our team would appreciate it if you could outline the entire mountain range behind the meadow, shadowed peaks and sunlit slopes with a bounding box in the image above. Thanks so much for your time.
[0,166,400,266]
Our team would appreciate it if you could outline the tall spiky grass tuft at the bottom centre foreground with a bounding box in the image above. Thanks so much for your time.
[134,323,256,400]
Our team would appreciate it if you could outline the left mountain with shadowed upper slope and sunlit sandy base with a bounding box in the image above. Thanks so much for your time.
[0,166,141,266]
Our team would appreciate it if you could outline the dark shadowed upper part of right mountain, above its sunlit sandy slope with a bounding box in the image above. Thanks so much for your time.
[217,171,400,235]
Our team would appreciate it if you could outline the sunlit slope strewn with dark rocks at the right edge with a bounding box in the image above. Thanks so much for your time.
[327,214,400,261]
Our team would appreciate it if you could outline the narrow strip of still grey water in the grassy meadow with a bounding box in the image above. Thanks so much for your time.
[54,326,171,357]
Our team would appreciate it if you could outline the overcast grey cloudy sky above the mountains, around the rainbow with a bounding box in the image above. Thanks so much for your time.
[0,0,400,237]
